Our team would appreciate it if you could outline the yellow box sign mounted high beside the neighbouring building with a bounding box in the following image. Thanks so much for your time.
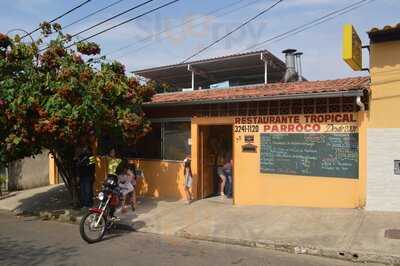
[342,24,362,71]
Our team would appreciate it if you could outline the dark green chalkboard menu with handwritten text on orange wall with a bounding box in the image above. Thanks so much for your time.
[260,133,358,179]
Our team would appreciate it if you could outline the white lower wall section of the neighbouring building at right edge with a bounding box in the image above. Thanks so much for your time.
[366,128,400,211]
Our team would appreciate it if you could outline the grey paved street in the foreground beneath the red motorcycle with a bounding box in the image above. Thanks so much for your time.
[0,212,384,266]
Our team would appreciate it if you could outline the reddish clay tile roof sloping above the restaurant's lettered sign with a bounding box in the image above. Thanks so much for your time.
[148,77,370,105]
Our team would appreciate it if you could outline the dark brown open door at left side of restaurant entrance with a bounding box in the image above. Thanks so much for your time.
[199,126,215,199]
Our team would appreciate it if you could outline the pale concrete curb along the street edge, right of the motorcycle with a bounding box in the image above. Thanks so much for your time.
[175,230,400,265]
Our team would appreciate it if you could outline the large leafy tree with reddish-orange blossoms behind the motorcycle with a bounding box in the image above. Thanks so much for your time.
[0,22,155,206]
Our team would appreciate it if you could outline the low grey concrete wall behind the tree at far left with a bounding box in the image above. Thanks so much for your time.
[8,151,49,190]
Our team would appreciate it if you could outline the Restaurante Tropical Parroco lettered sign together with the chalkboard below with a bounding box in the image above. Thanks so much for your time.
[234,113,359,179]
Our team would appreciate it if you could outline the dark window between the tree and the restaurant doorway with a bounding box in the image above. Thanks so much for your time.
[130,122,191,160]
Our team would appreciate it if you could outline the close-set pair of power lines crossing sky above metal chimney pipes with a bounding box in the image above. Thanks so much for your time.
[242,0,375,52]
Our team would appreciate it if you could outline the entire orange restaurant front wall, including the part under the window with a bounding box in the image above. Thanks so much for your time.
[48,112,368,208]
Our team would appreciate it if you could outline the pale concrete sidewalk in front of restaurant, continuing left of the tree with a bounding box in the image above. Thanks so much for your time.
[0,186,400,264]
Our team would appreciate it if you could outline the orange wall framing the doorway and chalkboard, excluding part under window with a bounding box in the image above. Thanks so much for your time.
[192,112,366,208]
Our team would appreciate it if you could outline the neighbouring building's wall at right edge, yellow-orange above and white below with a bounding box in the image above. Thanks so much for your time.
[366,38,400,211]
